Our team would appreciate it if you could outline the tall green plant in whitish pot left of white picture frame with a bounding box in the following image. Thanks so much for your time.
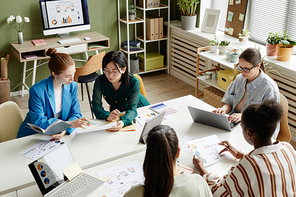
[177,0,199,30]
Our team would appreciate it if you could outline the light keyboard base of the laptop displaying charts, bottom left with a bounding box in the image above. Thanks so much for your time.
[46,173,104,197]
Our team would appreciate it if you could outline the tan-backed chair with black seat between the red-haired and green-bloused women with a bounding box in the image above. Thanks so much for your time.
[74,51,106,118]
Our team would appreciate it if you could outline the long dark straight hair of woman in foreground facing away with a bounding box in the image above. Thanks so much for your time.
[143,125,178,197]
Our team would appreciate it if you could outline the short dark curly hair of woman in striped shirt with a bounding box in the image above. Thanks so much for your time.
[242,99,283,142]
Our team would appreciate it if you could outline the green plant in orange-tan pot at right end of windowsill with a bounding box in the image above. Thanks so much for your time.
[276,31,296,61]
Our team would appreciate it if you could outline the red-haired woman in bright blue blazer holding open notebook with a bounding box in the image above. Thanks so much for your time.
[17,48,90,139]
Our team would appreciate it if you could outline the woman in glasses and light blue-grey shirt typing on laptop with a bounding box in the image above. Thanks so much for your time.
[213,48,280,139]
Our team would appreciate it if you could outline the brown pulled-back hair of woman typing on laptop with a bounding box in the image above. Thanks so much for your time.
[239,48,266,73]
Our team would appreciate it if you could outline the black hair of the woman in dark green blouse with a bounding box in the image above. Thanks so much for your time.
[103,51,130,87]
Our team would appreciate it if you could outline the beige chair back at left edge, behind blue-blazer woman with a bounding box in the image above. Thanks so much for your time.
[0,101,24,142]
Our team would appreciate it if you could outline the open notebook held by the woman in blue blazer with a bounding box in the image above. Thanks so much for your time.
[27,120,72,135]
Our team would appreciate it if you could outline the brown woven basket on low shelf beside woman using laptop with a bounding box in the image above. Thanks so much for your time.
[203,86,224,108]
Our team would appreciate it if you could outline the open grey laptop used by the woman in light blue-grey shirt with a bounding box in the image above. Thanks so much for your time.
[188,106,239,131]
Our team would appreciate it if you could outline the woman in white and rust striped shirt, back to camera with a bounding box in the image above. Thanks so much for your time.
[193,99,296,197]
